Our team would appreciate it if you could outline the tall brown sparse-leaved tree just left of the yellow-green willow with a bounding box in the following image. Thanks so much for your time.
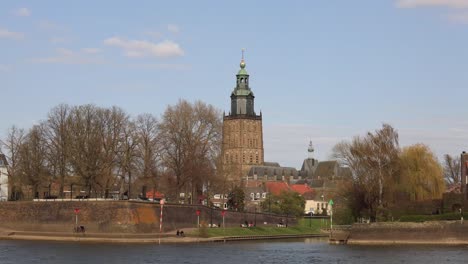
[334,124,399,221]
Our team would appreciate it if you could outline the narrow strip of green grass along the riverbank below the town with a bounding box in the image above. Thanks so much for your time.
[189,219,321,237]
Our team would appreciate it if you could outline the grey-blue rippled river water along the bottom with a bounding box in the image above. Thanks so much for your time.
[0,239,468,264]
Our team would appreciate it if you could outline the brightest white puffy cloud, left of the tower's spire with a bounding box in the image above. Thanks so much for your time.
[104,37,184,58]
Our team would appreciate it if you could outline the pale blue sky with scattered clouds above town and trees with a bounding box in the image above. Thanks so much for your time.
[0,0,468,168]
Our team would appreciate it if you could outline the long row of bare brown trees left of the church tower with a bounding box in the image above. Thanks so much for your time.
[0,100,222,200]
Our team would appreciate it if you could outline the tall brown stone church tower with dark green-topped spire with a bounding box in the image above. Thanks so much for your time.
[222,55,264,183]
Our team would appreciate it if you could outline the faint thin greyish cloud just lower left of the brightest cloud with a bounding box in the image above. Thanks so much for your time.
[30,48,104,64]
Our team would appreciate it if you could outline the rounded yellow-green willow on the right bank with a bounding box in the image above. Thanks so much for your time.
[400,144,445,201]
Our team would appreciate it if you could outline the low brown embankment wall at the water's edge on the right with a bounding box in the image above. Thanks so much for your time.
[348,221,468,245]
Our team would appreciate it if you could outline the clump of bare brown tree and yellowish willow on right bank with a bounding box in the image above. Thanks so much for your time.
[333,124,460,221]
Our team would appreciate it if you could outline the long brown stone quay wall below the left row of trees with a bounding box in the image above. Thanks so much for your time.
[0,200,296,233]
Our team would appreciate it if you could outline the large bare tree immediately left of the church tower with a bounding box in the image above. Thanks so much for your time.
[160,100,221,202]
